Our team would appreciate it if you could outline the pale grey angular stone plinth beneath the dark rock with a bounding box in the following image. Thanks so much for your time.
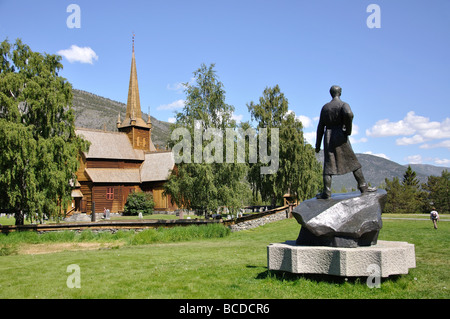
[267,240,416,277]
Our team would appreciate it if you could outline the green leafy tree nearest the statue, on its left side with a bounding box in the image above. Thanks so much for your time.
[247,85,322,204]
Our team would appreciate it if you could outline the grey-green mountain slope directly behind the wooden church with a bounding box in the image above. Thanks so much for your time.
[72,89,171,147]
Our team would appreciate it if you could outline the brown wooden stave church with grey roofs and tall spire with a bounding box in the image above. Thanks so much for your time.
[72,38,177,214]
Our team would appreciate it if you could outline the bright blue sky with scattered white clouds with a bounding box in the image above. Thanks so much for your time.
[0,0,450,167]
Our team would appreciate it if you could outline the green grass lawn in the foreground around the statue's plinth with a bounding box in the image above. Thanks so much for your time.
[0,219,450,299]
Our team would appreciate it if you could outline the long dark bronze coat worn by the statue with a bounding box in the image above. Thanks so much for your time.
[316,98,361,175]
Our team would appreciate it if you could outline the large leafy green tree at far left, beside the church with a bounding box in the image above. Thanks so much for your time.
[0,39,88,224]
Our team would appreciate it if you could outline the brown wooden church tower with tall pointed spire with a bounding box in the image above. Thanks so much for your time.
[117,34,155,151]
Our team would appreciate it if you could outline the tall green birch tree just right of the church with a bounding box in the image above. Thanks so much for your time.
[164,64,250,213]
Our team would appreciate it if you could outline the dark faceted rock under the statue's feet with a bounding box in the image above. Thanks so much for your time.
[292,189,386,247]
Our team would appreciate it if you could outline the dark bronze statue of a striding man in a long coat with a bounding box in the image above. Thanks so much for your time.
[316,85,376,199]
